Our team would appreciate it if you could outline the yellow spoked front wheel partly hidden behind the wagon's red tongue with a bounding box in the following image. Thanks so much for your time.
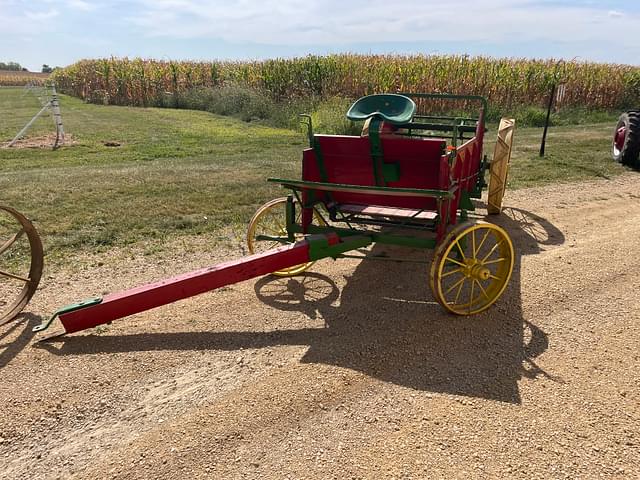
[247,197,325,277]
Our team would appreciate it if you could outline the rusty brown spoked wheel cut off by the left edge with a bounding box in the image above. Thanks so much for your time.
[0,205,44,325]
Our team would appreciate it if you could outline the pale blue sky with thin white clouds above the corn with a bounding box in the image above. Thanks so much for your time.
[0,0,640,71]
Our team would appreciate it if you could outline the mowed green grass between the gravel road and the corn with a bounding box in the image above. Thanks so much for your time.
[0,88,624,262]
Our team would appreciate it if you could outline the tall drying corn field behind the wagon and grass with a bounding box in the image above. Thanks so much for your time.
[54,54,640,109]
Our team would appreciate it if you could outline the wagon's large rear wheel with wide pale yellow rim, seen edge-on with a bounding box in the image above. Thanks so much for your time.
[487,118,516,214]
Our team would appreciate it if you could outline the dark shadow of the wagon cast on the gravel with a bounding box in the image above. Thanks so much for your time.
[38,208,564,404]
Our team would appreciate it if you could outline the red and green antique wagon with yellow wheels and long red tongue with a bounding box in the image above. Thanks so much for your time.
[22,94,514,333]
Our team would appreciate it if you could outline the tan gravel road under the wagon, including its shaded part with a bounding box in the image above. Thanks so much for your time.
[0,174,640,480]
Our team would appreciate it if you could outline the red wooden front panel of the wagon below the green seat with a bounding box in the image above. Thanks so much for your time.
[302,135,449,212]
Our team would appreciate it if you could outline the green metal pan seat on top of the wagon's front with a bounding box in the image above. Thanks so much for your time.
[347,93,416,125]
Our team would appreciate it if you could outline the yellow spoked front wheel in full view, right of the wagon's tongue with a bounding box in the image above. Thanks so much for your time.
[429,221,514,315]
